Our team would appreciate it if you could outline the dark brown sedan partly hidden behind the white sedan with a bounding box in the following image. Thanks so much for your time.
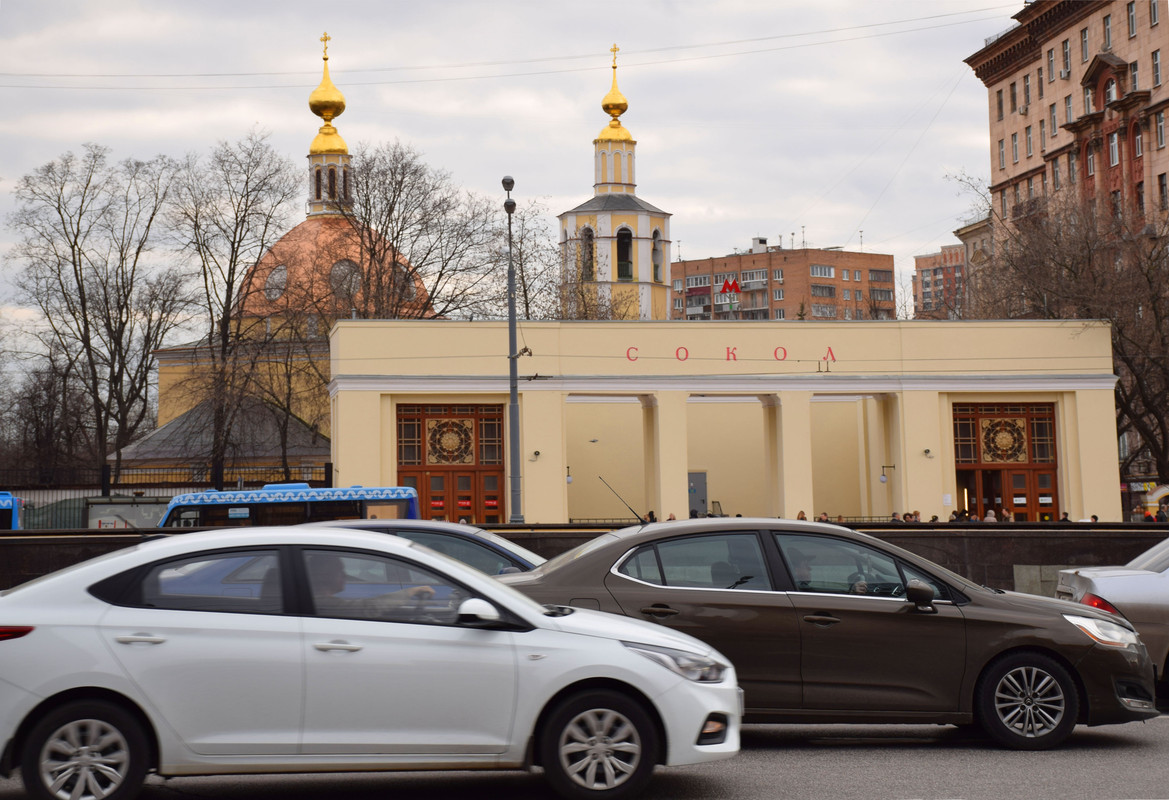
[500,517,1157,750]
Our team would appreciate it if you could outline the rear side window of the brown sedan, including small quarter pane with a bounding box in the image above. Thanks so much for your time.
[617,533,772,589]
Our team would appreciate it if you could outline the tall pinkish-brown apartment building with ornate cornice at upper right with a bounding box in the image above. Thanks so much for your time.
[966,0,1169,221]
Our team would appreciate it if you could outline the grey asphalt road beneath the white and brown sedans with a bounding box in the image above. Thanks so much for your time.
[0,717,1169,800]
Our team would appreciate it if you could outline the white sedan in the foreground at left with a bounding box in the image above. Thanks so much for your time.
[0,527,741,800]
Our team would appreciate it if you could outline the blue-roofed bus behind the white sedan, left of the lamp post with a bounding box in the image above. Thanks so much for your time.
[159,483,420,527]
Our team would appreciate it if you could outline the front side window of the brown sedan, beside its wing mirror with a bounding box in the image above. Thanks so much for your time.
[775,533,905,595]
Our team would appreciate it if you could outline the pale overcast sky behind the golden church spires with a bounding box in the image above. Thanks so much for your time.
[0,0,1023,290]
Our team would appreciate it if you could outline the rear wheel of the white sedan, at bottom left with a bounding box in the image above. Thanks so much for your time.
[21,701,147,800]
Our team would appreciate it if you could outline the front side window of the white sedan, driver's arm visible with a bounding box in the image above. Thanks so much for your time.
[304,550,468,625]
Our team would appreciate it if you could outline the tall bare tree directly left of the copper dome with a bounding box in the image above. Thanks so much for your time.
[172,131,300,485]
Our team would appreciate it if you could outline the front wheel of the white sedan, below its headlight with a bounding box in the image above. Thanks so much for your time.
[538,690,659,800]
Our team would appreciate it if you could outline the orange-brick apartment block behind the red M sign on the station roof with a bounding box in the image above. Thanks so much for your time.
[670,237,897,320]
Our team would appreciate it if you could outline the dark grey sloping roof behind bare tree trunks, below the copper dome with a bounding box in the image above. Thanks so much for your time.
[111,399,330,464]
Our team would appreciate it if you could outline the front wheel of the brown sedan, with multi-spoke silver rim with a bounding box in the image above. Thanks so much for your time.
[975,653,1080,750]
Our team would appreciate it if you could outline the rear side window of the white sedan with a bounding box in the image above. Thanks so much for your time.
[141,550,283,613]
